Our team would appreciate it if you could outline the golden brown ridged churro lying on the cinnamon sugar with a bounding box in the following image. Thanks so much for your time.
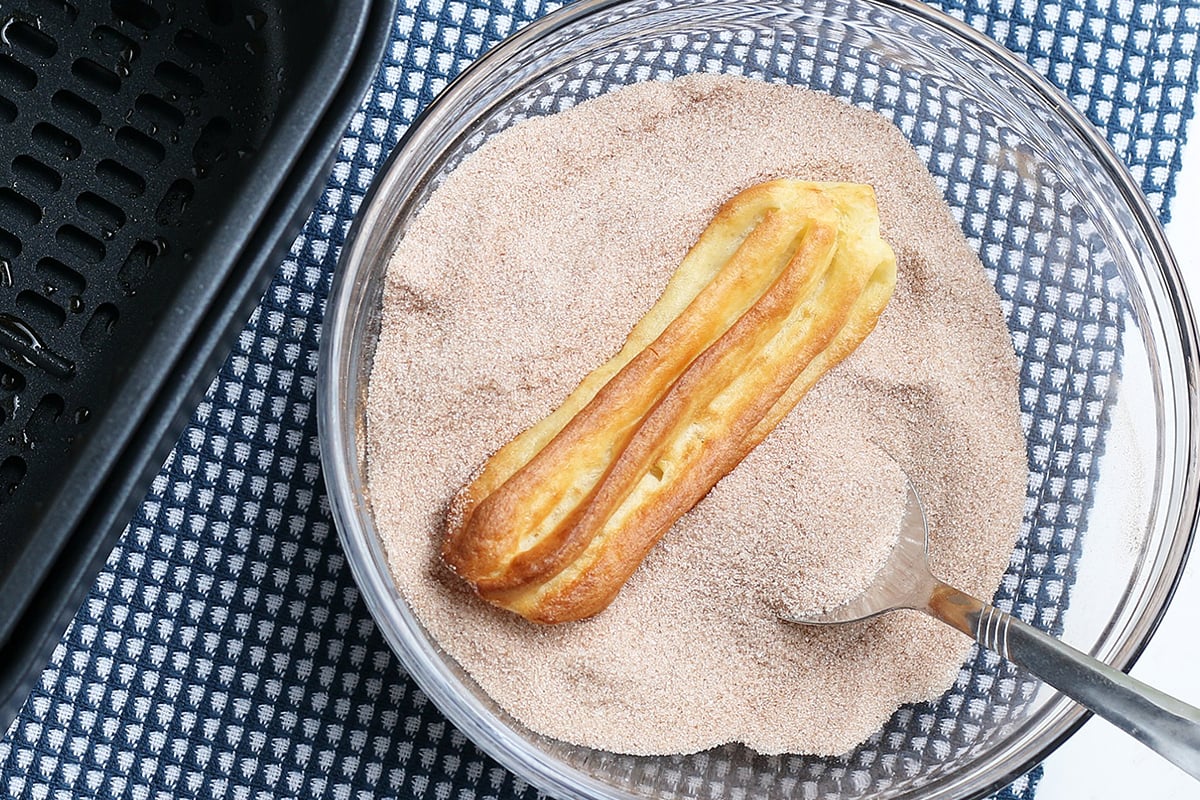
[442,180,895,622]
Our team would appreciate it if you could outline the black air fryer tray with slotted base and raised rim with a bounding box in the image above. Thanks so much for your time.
[0,0,395,730]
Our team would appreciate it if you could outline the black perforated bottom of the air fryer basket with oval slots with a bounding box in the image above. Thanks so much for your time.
[0,0,286,578]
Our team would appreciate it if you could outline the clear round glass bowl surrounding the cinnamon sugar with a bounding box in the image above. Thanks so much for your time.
[318,0,1198,799]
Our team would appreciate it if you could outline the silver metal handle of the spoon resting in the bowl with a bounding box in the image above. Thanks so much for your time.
[922,582,1200,780]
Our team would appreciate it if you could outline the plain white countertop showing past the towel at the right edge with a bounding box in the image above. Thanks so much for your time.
[1036,137,1200,800]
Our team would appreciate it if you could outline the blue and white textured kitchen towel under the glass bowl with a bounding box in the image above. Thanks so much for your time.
[0,0,1200,800]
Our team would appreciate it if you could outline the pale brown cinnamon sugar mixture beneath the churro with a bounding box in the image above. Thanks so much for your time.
[367,76,1026,754]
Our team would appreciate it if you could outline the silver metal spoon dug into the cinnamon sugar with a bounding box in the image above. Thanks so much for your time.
[782,475,1200,780]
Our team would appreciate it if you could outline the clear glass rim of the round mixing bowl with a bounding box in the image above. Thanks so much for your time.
[317,0,1200,800]
